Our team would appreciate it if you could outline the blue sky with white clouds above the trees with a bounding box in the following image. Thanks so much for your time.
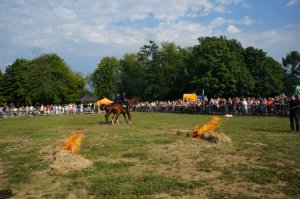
[0,0,300,76]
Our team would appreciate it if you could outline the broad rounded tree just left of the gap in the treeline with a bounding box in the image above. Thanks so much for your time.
[29,54,87,104]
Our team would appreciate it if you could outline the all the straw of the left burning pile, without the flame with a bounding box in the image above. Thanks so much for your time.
[41,141,93,174]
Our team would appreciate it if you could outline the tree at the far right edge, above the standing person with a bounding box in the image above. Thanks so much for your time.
[282,51,300,95]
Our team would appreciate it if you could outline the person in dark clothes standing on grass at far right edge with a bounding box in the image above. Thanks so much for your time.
[289,95,300,132]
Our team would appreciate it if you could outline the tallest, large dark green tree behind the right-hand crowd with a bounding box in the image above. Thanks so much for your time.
[191,37,245,97]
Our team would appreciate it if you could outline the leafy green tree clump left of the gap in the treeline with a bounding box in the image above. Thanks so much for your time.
[4,54,86,105]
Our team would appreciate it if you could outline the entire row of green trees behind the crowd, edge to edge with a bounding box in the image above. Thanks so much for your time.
[0,36,300,105]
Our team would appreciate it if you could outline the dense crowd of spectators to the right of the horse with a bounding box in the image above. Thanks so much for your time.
[135,94,289,116]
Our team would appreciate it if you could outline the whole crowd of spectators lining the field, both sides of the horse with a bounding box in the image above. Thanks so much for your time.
[0,94,289,118]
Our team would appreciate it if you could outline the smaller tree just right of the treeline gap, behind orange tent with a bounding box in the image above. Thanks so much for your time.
[89,57,121,98]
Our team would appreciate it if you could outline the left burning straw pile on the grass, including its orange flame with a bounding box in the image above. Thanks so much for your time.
[41,132,93,174]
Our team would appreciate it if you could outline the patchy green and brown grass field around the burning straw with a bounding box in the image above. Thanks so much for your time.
[0,112,300,199]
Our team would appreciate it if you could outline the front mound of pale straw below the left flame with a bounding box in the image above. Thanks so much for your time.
[50,150,93,174]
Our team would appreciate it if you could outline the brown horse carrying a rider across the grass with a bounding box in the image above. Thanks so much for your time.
[105,103,131,124]
